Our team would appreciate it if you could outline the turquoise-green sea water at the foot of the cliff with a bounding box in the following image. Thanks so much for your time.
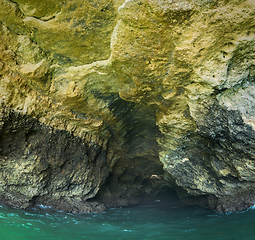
[0,203,255,240]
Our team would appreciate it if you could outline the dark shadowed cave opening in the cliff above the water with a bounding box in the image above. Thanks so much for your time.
[89,95,183,207]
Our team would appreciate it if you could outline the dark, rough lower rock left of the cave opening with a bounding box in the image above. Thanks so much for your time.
[0,107,110,212]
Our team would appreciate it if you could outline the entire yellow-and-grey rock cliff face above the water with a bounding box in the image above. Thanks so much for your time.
[0,0,255,212]
